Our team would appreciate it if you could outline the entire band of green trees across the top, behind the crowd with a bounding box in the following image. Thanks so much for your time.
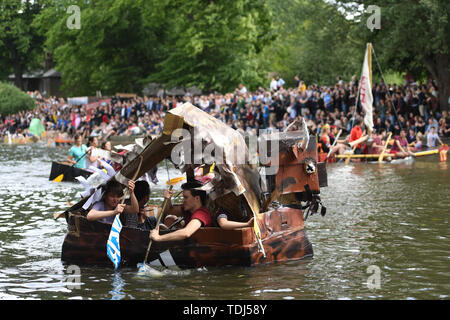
[0,0,450,108]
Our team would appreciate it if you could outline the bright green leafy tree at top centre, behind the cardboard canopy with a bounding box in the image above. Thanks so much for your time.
[147,0,274,91]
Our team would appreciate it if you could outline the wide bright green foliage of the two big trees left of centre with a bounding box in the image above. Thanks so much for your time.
[34,0,271,95]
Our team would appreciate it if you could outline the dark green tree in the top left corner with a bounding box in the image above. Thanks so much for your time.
[0,0,47,89]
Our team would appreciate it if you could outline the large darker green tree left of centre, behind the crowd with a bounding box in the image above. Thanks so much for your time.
[34,0,164,95]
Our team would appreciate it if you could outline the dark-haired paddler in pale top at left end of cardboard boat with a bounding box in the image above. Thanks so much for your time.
[86,180,139,223]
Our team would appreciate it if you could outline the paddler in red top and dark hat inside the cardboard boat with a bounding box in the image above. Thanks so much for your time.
[150,181,212,241]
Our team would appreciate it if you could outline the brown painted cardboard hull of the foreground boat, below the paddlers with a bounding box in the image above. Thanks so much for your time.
[61,208,313,268]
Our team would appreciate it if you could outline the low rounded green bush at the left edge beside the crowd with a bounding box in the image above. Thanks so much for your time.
[0,82,35,115]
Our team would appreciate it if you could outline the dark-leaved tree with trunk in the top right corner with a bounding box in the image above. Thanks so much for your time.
[338,0,450,110]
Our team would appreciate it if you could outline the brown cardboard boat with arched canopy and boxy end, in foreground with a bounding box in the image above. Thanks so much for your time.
[61,103,327,268]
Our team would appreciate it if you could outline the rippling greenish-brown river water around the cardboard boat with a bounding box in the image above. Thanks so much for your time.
[0,144,450,300]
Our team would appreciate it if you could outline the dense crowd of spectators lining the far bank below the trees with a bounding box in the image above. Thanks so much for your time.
[0,77,450,140]
